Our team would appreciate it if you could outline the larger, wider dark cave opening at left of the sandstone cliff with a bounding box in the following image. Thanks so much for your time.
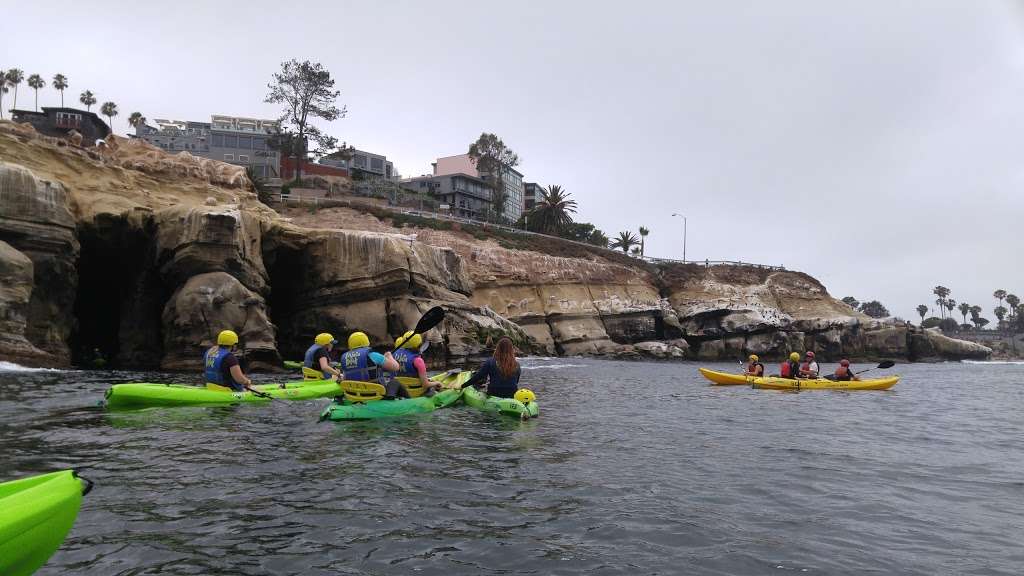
[70,216,167,368]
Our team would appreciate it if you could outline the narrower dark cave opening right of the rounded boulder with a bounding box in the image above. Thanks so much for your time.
[263,243,309,360]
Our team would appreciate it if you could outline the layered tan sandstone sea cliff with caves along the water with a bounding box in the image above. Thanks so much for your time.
[0,121,991,370]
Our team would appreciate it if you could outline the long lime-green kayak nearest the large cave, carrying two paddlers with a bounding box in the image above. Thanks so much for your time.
[106,380,341,409]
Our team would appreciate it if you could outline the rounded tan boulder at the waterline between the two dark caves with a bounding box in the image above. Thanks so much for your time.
[161,272,281,370]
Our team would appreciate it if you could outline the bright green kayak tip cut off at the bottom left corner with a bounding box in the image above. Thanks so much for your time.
[0,470,92,576]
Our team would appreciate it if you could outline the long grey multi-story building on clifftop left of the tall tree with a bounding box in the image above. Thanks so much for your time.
[135,115,281,178]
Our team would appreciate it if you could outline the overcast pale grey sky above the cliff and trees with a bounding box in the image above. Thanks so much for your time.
[8,0,1024,320]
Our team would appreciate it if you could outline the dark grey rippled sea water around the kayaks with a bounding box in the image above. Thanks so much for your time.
[0,359,1024,575]
